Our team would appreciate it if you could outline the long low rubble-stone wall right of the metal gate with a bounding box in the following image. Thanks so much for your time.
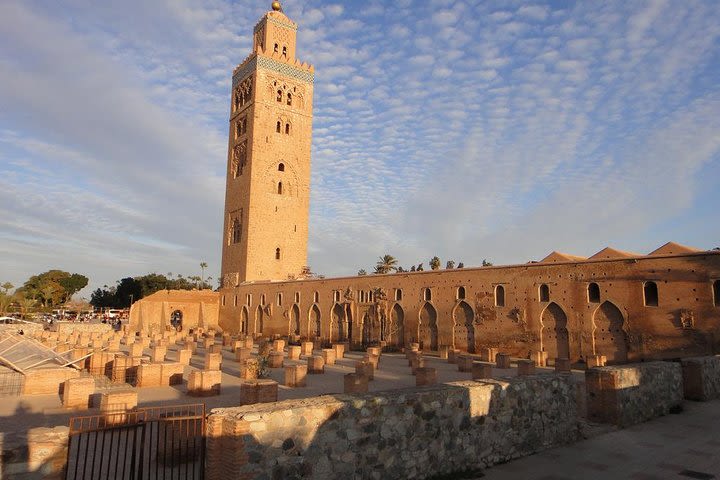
[206,375,579,480]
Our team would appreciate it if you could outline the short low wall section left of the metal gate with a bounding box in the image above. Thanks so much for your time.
[0,426,69,480]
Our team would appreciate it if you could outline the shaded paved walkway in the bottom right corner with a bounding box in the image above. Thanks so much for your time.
[483,400,720,480]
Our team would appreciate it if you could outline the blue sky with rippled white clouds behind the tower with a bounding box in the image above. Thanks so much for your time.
[0,0,720,297]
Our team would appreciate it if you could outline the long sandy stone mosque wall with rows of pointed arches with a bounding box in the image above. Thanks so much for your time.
[219,248,720,366]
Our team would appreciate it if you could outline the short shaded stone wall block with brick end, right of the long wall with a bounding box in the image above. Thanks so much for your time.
[585,362,683,427]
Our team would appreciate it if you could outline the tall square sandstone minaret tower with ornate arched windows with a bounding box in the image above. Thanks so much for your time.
[222,2,314,288]
